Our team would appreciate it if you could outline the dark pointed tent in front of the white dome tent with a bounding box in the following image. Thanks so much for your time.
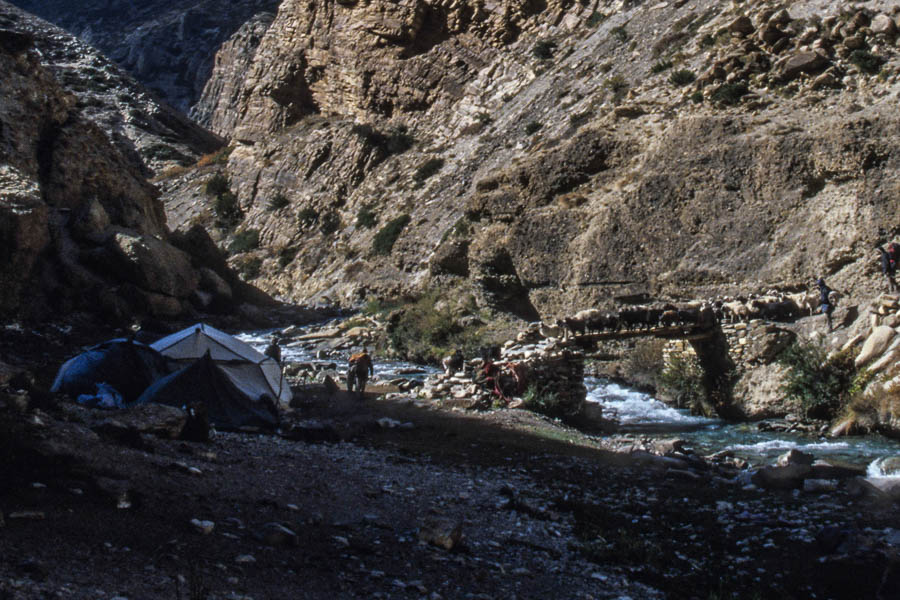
[138,352,278,429]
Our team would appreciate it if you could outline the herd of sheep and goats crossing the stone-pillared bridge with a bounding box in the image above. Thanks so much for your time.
[545,291,819,339]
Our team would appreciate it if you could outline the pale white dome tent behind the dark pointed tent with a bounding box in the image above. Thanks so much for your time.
[151,323,293,406]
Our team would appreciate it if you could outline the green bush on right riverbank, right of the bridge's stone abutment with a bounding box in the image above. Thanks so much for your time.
[778,342,858,419]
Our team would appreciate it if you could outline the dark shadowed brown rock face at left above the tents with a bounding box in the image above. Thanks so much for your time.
[0,22,253,324]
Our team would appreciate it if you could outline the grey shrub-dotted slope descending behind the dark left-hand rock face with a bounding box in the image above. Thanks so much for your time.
[0,2,223,176]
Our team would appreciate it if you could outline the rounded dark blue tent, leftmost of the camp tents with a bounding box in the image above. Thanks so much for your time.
[50,339,169,405]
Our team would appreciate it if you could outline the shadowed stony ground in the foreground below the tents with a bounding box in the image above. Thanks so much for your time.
[0,316,900,599]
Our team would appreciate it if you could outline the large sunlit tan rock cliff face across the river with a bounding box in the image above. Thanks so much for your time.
[165,0,900,318]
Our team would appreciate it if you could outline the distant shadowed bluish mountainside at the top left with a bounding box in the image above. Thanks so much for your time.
[7,0,279,113]
